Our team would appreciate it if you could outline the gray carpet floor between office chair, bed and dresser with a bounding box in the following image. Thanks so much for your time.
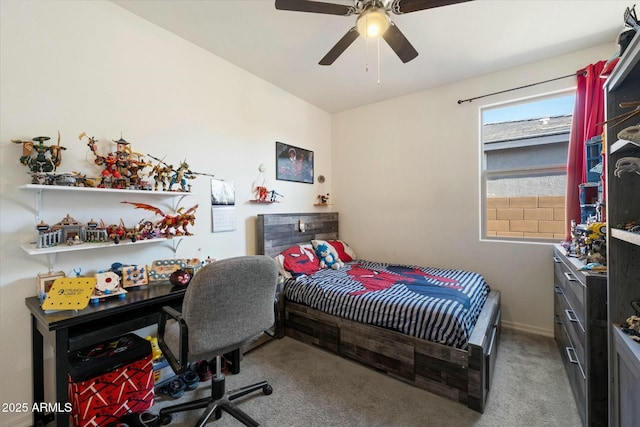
[151,329,581,427]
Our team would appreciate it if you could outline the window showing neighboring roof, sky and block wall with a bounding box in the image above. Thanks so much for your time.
[481,92,575,242]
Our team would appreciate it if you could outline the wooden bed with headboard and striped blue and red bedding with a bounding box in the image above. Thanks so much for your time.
[257,212,500,412]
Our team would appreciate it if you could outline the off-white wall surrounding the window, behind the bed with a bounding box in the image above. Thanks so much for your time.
[332,43,615,336]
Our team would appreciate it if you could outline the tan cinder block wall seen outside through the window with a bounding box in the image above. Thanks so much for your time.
[487,196,565,239]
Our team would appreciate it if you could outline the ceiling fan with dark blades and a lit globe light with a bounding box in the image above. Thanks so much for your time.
[276,0,470,65]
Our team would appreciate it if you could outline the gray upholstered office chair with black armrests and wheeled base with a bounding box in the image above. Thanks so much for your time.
[158,255,278,426]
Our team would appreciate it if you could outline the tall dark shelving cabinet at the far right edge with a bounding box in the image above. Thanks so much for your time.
[604,33,640,427]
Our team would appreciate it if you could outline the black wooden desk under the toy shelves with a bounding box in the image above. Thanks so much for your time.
[25,283,185,426]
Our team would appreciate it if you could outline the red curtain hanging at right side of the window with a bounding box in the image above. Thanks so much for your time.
[565,61,606,241]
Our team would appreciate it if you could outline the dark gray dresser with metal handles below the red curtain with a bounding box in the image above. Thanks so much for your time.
[553,245,608,427]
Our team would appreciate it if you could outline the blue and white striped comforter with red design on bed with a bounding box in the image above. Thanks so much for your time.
[284,260,490,350]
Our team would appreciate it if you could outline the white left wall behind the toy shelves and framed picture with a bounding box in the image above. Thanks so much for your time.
[0,0,333,425]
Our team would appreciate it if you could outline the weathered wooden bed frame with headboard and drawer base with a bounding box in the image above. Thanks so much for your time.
[257,212,500,412]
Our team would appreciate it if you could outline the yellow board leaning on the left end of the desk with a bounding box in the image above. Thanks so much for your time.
[42,277,96,310]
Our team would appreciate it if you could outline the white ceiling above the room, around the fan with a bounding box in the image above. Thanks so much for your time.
[112,0,633,113]
